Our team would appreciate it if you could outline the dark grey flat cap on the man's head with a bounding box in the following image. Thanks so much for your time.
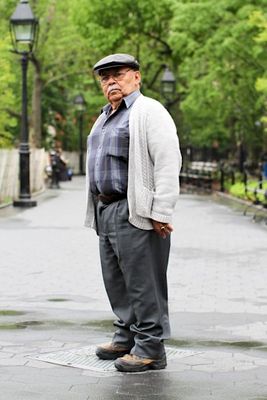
[93,54,140,73]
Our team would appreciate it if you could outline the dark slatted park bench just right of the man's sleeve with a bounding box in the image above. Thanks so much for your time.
[180,161,218,189]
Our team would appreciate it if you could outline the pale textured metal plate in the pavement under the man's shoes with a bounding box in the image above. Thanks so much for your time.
[32,346,199,372]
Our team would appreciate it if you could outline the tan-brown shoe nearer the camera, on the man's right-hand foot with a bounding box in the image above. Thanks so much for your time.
[115,354,167,372]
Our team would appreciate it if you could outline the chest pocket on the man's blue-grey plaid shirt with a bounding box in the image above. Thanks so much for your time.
[107,128,129,161]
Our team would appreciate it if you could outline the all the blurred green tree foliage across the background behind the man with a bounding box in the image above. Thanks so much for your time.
[0,0,267,155]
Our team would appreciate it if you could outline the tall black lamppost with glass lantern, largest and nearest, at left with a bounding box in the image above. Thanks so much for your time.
[10,0,38,207]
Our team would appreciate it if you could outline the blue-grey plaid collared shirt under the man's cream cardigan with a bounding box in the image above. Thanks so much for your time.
[88,90,140,195]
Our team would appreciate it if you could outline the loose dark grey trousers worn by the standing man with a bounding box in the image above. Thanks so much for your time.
[97,199,170,358]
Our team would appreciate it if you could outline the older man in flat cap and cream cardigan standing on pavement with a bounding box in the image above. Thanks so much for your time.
[85,54,181,372]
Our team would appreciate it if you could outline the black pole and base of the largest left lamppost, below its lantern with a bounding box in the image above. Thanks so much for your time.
[13,52,37,207]
